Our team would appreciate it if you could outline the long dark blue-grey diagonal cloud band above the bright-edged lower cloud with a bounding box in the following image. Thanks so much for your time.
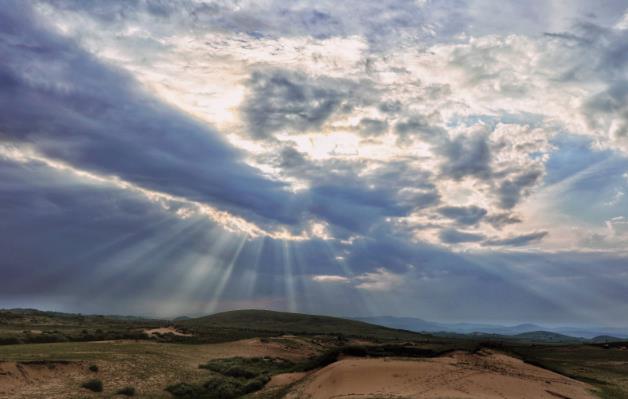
[0,2,298,228]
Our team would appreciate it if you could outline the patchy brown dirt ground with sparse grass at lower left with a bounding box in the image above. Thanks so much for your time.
[0,338,312,399]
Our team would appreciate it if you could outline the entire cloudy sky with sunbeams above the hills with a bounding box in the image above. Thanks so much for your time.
[0,0,628,327]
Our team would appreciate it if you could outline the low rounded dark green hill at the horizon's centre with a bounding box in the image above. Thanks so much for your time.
[176,310,431,340]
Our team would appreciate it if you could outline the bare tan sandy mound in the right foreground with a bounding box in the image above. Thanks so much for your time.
[287,351,595,399]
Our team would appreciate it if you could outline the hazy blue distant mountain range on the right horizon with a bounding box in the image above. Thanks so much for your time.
[354,316,628,339]
